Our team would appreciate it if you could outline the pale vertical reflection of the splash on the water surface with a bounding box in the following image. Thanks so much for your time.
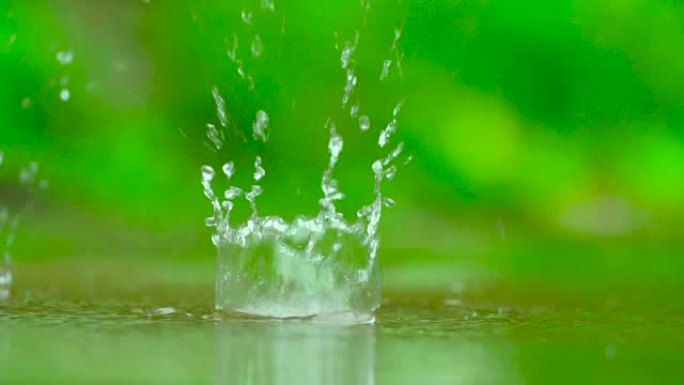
[215,322,376,385]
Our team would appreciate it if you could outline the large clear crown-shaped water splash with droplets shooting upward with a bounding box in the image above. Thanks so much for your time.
[201,0,404,322]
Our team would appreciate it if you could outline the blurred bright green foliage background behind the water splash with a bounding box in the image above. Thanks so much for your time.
[0,0,684,301]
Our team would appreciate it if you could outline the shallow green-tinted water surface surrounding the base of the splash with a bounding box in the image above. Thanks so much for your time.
[0,260,684,384]
